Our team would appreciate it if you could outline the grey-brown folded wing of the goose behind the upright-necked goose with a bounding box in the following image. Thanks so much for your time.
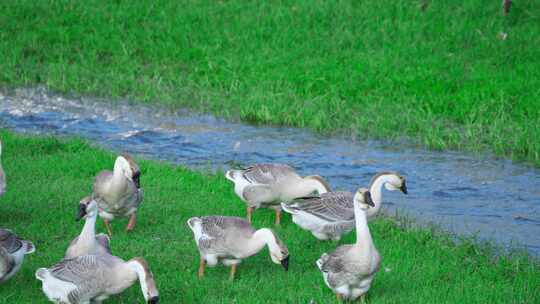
[284,192,354,222]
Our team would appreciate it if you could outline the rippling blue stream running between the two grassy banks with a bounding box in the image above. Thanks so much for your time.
[0,89,540,255]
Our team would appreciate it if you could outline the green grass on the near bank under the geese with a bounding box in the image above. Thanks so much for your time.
[0,130,540,304]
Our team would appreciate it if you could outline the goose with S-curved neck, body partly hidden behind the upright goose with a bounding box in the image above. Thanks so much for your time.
[281,171,408,241]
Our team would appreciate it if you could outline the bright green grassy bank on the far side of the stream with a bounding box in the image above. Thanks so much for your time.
[0,0,540,165]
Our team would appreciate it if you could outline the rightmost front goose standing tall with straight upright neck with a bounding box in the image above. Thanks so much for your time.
[316,188,381,300]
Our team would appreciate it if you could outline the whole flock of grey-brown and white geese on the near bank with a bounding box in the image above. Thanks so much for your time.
[0,142,407,304]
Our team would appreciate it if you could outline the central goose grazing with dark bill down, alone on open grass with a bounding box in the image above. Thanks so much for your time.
[187,216,289,280]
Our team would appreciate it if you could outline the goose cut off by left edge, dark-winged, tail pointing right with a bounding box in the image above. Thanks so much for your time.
[0,228,35,283]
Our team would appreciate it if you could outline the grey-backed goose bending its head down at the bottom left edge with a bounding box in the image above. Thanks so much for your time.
[35,255,159,304]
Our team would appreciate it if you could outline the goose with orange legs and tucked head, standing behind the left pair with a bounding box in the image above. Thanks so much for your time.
[94,154,143,235]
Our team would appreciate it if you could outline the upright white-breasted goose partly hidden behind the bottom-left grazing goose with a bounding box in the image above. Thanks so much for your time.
[64,196,111,259]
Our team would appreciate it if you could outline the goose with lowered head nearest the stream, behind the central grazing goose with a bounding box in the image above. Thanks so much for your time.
[225,164,331,225]
